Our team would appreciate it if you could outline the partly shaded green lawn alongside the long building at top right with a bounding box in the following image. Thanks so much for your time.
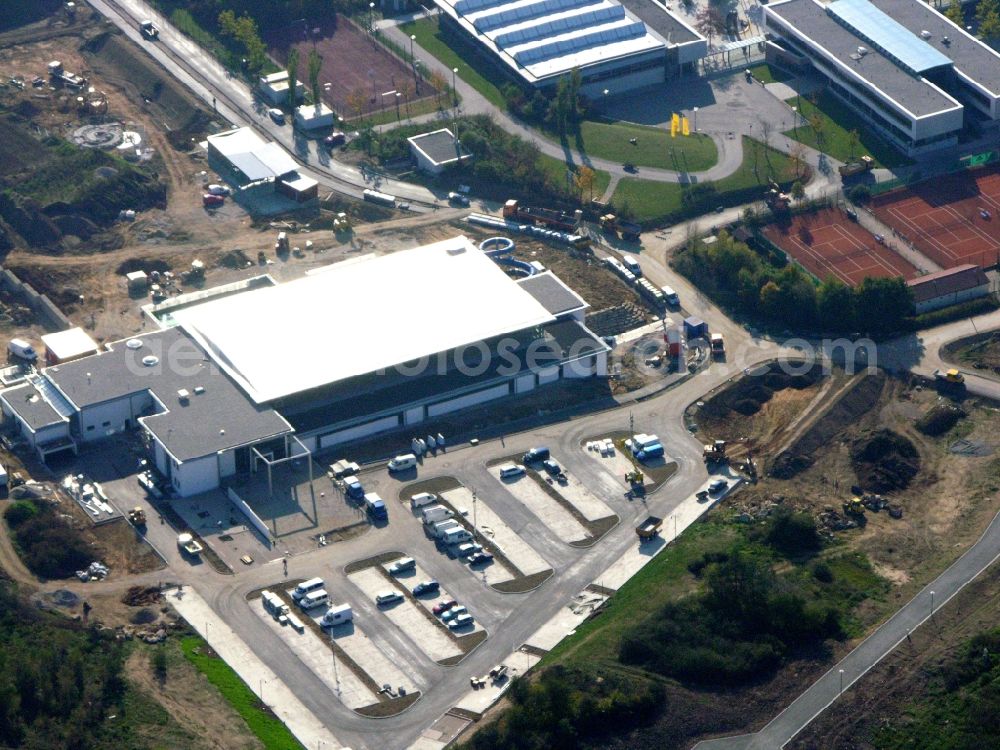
[785,92,913,168]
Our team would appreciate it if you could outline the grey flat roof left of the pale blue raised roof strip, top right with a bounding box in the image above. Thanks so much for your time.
[765,0,957,117]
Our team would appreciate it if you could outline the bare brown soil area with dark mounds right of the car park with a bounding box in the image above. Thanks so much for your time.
[700,370,1000,624]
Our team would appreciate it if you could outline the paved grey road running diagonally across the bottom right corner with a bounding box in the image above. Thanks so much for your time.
[695,506,1000,750]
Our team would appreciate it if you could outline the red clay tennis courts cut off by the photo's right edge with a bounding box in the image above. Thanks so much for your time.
[872,167,1000,268]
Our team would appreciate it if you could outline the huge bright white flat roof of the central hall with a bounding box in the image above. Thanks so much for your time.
[174,237,555,403]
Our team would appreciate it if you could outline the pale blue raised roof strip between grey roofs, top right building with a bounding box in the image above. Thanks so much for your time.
[826,0,951,75]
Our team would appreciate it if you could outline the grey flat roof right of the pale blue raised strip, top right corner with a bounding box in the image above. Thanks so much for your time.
[872,0,1000,94]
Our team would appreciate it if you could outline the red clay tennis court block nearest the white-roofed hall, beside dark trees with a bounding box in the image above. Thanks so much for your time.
[764,208,917,286]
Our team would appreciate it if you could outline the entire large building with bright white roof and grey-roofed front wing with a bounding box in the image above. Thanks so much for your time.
[0,237,608,497]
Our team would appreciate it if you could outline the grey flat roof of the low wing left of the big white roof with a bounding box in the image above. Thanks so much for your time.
[45,328,291,461]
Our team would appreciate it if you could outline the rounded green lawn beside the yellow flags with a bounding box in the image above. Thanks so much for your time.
[570,120,719,172]
